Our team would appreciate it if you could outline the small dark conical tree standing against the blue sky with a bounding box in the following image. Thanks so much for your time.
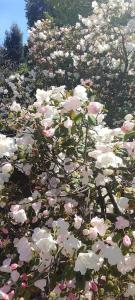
[4,24,23,64]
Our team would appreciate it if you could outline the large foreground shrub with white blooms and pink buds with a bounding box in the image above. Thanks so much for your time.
[0,85,135,300]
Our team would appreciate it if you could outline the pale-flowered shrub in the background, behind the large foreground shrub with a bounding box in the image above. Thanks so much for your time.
[29,0,135,125]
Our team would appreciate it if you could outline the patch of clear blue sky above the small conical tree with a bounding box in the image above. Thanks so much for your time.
[0,0,27,44]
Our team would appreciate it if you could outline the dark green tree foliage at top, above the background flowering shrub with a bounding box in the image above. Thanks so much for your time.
[25,0,92,27]
